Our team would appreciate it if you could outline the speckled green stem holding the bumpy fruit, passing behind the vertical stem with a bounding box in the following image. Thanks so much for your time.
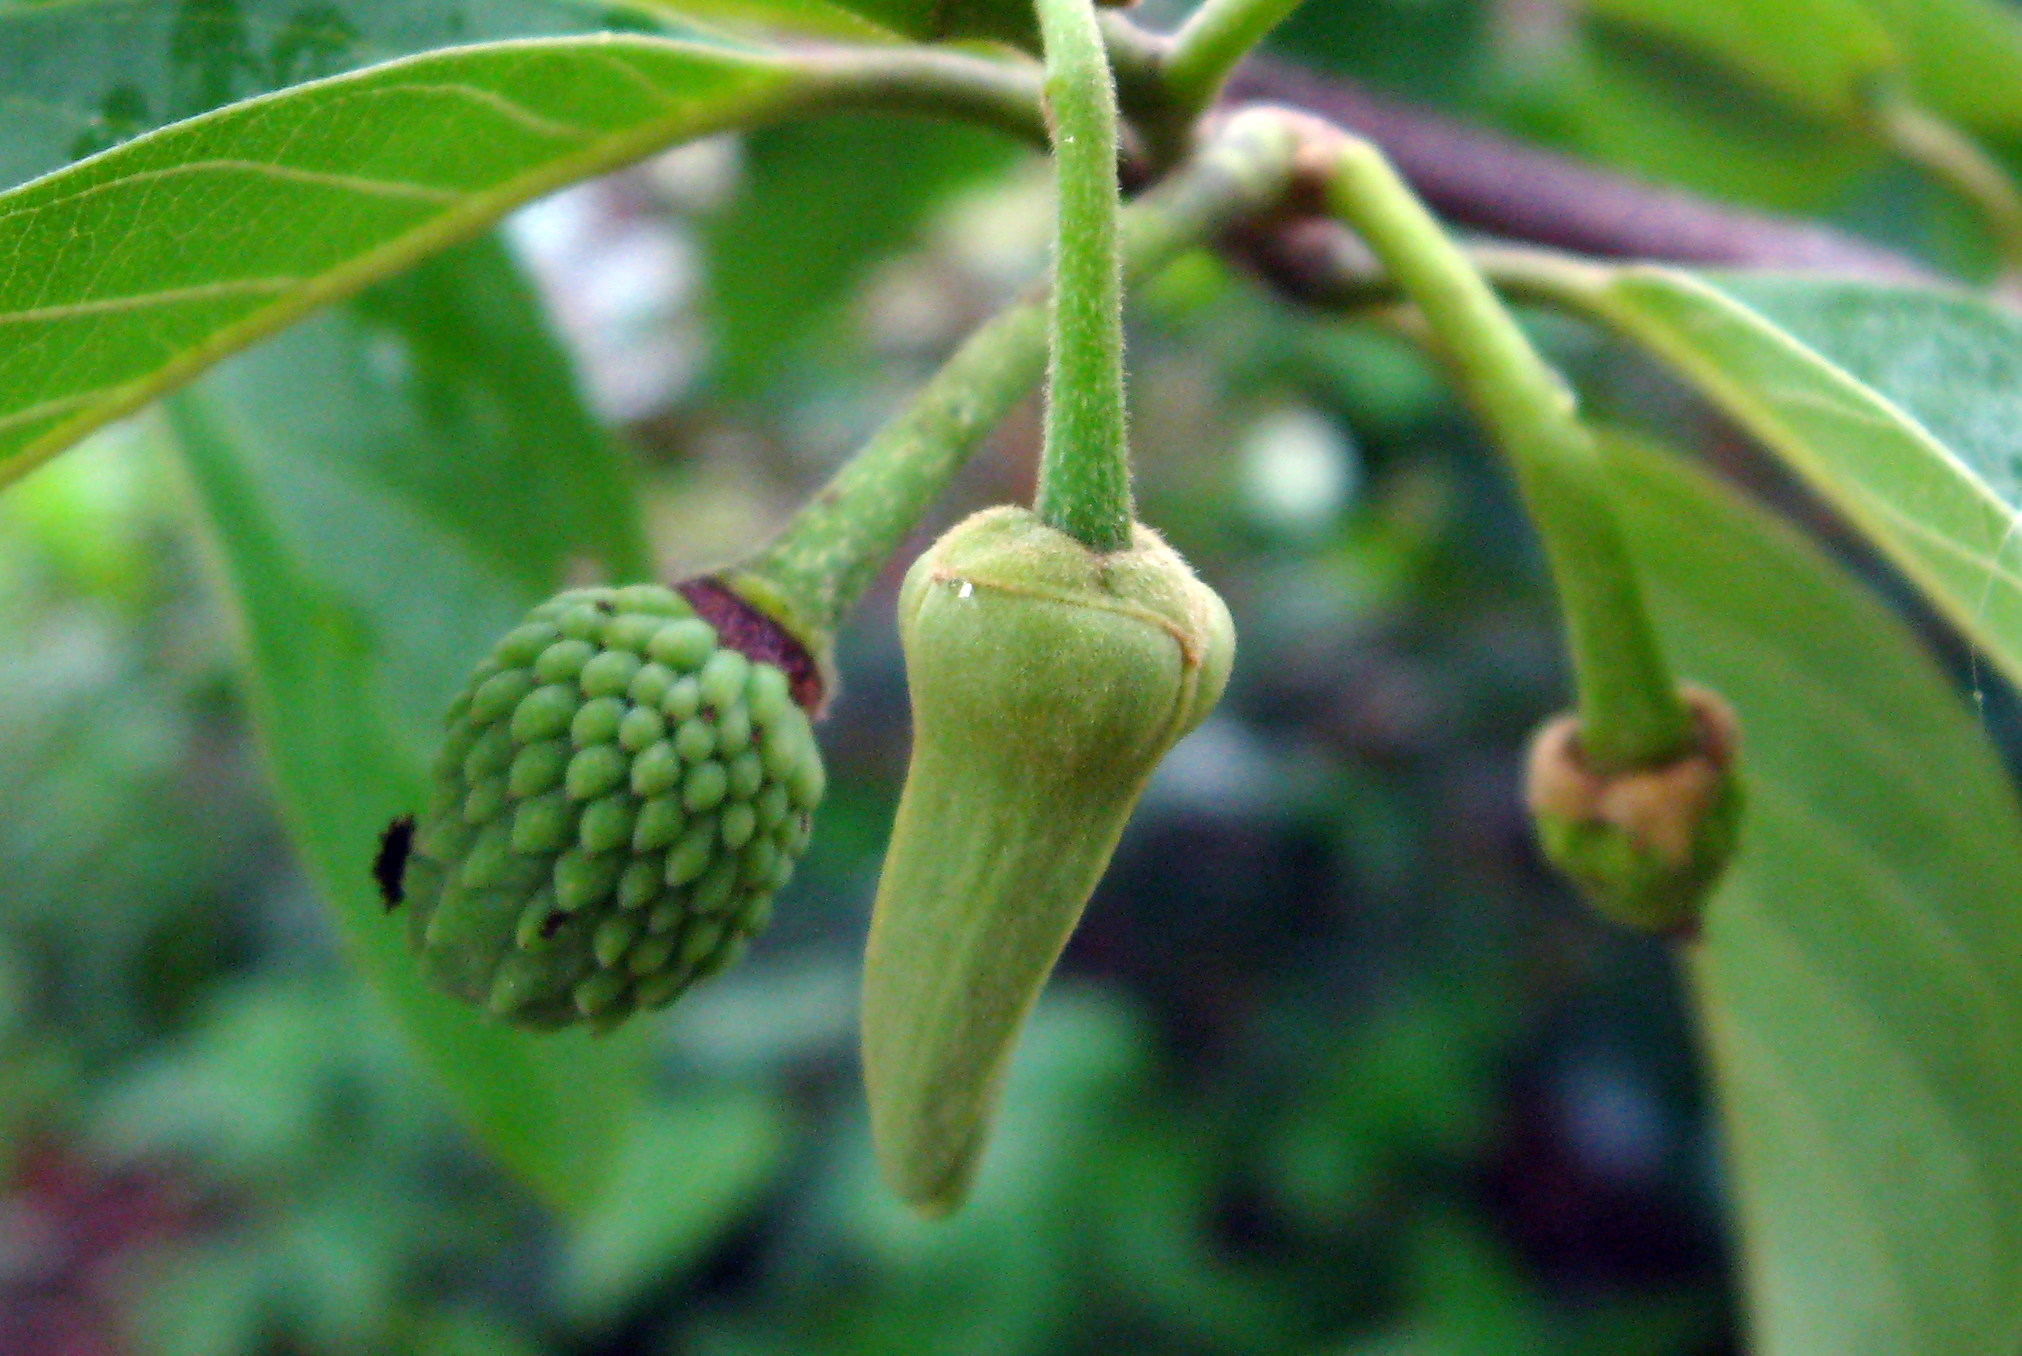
[730,113,1296,647]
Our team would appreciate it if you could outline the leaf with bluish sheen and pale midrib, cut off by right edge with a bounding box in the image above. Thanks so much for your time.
[1569,269,2022,699]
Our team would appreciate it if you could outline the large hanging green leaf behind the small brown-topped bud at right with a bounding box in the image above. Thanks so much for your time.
[1612,432,2022,1356]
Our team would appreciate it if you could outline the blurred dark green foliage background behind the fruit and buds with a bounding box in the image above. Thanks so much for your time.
[0,0,2002,1356]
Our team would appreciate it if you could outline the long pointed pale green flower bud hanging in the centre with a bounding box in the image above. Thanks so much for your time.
[857,507,1235,1213]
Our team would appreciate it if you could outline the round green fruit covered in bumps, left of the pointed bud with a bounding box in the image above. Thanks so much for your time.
[404,584,823,1029]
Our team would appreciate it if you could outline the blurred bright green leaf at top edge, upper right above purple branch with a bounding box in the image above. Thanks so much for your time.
[1585,0,1897,117]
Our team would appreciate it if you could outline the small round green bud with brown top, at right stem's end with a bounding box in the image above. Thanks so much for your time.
[1525,687,1741,940]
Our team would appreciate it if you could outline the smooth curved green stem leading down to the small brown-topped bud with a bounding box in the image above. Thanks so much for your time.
[1326,139,1692,770]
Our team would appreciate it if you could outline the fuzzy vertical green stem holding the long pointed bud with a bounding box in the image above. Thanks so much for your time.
[1033,0,1130,554]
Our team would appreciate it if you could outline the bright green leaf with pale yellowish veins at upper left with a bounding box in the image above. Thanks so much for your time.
[0,38,845,483]
